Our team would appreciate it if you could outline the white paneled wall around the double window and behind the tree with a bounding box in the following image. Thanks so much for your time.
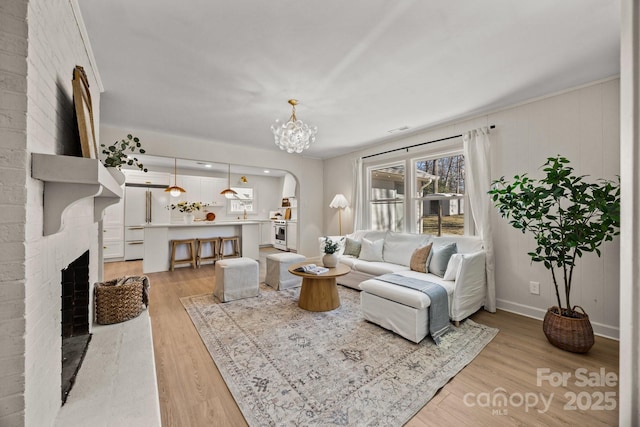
[324,79,620,337]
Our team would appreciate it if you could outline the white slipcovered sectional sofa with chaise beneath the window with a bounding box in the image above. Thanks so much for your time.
[322,231,487,343]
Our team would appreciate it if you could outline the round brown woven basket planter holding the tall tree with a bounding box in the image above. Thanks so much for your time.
[542,305,595,353]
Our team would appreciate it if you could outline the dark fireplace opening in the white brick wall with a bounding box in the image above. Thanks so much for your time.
[61,251,91,405]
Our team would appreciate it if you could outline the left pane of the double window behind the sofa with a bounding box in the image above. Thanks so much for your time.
[368,162,405,231]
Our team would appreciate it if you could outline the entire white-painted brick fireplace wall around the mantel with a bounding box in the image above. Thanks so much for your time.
[0,0,100,427]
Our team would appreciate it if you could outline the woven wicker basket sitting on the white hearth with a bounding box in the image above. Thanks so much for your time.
[94,276,148,325]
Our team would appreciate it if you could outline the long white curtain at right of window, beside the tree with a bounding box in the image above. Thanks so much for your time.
[462,128,496,313]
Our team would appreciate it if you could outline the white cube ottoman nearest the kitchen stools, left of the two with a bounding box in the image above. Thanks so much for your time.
[213,258,259,302]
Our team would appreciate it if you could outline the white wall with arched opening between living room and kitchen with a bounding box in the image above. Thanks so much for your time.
[100,124,324,256]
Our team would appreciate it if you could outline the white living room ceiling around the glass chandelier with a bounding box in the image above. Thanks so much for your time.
[79,0,620,158]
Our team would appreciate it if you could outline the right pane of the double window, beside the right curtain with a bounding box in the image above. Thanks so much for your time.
[414,154,465,236]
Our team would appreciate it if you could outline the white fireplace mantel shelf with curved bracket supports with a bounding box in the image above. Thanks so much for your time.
[31,153,123,236]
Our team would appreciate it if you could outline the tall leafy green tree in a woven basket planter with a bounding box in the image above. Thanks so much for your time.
[489,156,620,353]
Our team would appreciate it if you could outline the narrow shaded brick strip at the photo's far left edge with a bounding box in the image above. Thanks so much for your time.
[0,0,27,426]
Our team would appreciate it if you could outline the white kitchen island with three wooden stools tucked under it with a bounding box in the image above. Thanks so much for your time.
[142,220,260,274]
